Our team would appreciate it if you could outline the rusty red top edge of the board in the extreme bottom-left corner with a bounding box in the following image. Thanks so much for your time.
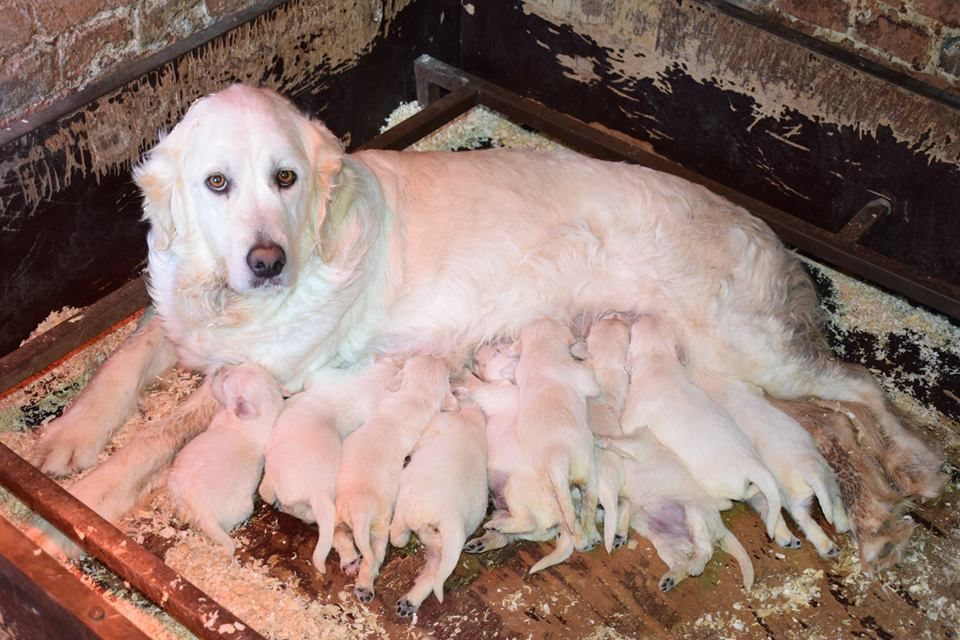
[0,517,148,640]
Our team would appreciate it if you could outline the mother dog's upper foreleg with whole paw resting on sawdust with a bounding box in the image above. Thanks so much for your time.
[31,310,177,476]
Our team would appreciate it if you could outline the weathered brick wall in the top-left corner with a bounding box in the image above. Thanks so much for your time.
[0,0,257,126]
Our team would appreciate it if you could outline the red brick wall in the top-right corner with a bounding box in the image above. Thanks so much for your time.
[731,0,960,93]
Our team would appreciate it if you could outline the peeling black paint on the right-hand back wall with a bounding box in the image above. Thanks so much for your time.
[462,0,960,282]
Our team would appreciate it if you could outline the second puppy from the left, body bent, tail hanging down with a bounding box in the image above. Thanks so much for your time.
[260,361,399,573]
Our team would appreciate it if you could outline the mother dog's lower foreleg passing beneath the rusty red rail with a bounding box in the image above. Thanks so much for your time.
[28,382,220,557]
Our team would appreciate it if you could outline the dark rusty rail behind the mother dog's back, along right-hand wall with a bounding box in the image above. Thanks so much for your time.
[415,55,960,320]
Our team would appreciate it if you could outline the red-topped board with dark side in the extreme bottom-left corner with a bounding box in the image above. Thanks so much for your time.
[0,517,147,640]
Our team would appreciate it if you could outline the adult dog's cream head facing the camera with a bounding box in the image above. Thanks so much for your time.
[134,85,343,293]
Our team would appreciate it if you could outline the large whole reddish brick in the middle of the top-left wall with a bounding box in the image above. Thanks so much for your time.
[58,14,134,86]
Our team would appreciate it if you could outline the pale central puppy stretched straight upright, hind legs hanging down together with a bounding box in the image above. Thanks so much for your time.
[506,318,600,571]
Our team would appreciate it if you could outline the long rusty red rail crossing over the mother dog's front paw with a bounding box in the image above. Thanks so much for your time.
[0,444,262,640]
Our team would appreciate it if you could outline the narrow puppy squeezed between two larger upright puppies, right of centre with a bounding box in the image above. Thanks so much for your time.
[587,317,630,553]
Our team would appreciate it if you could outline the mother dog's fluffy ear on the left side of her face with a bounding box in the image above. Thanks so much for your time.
[133,134,179,251]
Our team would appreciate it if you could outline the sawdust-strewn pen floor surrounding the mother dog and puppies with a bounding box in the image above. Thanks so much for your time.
[0,104,960,640]
